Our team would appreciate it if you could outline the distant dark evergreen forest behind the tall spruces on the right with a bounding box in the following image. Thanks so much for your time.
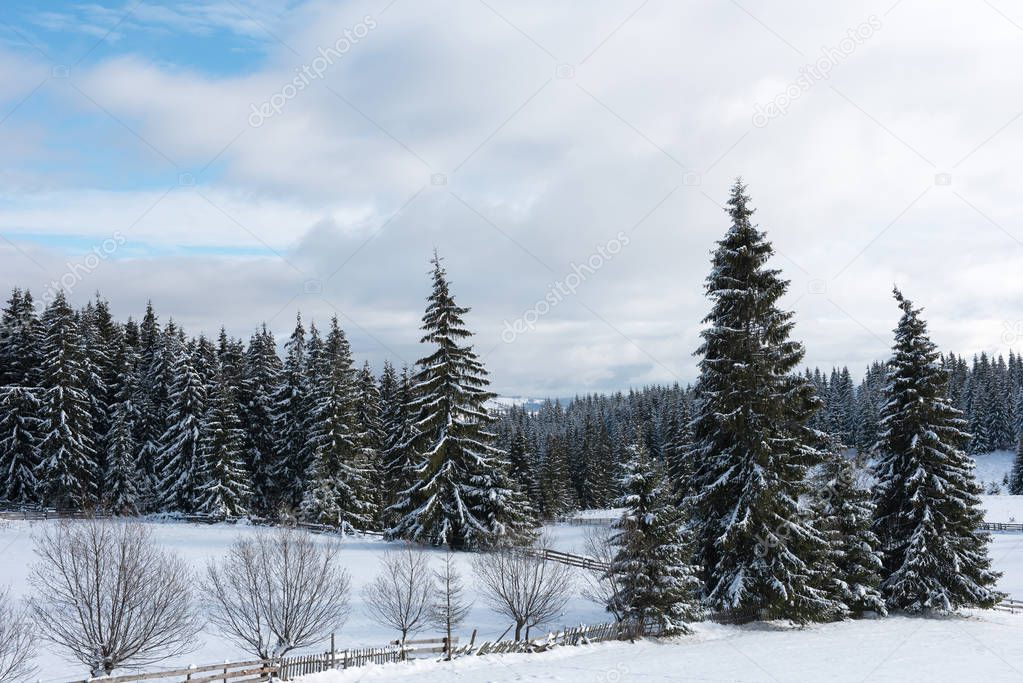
[497,335,1023,501]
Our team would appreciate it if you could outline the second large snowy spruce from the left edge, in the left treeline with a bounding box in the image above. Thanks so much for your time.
[36,290,96,510]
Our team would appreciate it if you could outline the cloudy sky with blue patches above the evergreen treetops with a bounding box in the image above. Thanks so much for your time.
[0,0,1023,397]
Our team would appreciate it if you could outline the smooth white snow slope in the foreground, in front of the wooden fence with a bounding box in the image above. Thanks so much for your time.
[302,612,1023,683]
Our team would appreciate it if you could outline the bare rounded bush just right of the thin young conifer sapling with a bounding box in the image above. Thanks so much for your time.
[473,539,573,640]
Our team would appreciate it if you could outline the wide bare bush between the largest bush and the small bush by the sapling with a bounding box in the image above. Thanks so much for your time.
[203,529,350,659]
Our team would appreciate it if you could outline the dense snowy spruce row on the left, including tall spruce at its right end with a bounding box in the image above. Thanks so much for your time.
[0,256,535,547]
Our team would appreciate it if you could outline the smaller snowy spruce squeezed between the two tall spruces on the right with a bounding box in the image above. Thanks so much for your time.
[816,454,888,617]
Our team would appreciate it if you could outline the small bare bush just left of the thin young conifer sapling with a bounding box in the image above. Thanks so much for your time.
[362,544,433,645]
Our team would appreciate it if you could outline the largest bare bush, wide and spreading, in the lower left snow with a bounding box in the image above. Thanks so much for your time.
[30,520,202,676]
